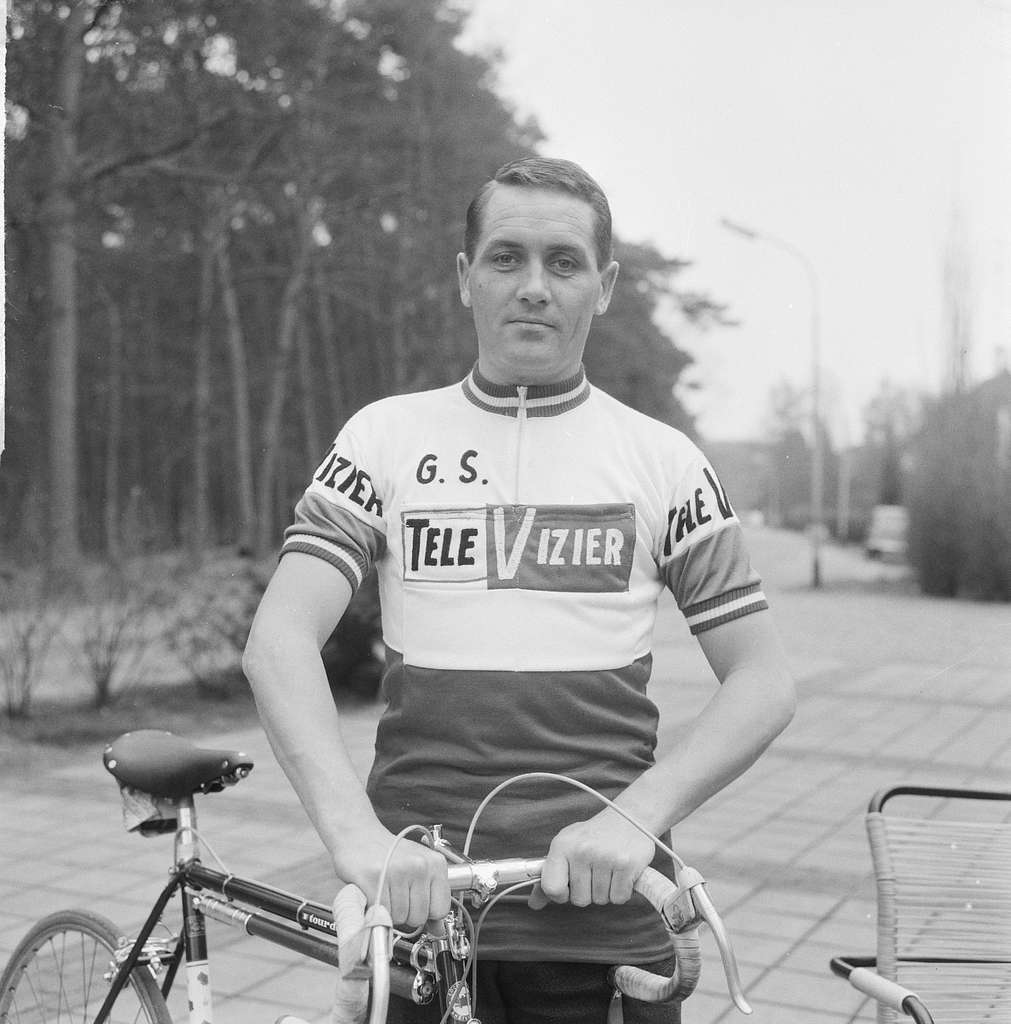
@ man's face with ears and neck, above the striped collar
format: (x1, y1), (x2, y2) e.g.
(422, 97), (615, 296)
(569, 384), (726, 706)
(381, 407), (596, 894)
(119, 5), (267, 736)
(457, 184), (618, 384)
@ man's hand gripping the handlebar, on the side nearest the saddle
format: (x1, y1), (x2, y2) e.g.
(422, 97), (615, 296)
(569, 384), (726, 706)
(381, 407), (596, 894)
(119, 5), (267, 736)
(335, 829), (450, 931)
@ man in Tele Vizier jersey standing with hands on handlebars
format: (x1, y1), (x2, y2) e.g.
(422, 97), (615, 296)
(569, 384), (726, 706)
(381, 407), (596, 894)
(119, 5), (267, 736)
(245, 158), (795, 1024)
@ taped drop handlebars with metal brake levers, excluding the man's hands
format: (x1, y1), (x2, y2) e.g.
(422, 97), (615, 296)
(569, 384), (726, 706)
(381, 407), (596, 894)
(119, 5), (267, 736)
(335, 858), (752, 1024)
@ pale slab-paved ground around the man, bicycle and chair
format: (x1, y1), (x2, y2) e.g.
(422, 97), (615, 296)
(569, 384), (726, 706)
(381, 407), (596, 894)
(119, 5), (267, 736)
(0, 531), (1011, 1024)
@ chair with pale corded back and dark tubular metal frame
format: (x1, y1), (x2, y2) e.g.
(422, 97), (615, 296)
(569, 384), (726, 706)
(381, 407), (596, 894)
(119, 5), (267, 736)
(831, 785), (1011, 1024)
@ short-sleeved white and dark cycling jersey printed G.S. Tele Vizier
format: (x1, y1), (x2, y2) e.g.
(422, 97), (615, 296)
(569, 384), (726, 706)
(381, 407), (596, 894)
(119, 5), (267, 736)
(283, 368), (767, 963)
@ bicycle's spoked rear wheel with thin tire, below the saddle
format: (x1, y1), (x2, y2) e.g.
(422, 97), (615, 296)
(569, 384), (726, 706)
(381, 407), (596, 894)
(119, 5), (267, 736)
(0, 910), (172, 1024)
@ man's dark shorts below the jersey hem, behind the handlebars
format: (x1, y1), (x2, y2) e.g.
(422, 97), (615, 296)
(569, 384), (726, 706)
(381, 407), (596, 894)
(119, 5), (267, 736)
(386, 959), (681, 1024)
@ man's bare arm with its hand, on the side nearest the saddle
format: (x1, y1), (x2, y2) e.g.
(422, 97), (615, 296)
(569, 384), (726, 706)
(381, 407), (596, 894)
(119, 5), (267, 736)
(243, 552), (450, 927)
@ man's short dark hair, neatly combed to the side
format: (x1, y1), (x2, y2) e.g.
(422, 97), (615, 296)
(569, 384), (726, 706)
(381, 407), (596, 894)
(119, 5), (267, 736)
(463, 157), (614, 267)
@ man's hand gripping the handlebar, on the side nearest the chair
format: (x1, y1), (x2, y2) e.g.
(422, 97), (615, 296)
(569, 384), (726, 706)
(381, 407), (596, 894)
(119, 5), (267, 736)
(529, 808), (655, 910)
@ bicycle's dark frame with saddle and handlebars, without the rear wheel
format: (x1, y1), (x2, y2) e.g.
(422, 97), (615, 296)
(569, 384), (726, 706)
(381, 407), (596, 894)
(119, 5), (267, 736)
(92, 731), (751, 1024)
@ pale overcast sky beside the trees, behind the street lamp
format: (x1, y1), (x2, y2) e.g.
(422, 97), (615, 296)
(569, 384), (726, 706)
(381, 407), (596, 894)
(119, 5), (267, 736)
(465, 0), (1011, 442)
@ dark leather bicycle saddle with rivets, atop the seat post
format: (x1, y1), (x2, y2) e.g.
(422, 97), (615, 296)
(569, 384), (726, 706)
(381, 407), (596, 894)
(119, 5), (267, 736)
(101, 729), (253, 799)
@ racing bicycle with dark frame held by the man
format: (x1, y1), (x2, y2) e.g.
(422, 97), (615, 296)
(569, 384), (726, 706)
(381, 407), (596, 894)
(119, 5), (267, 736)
(0, 729), (751, 1024)
